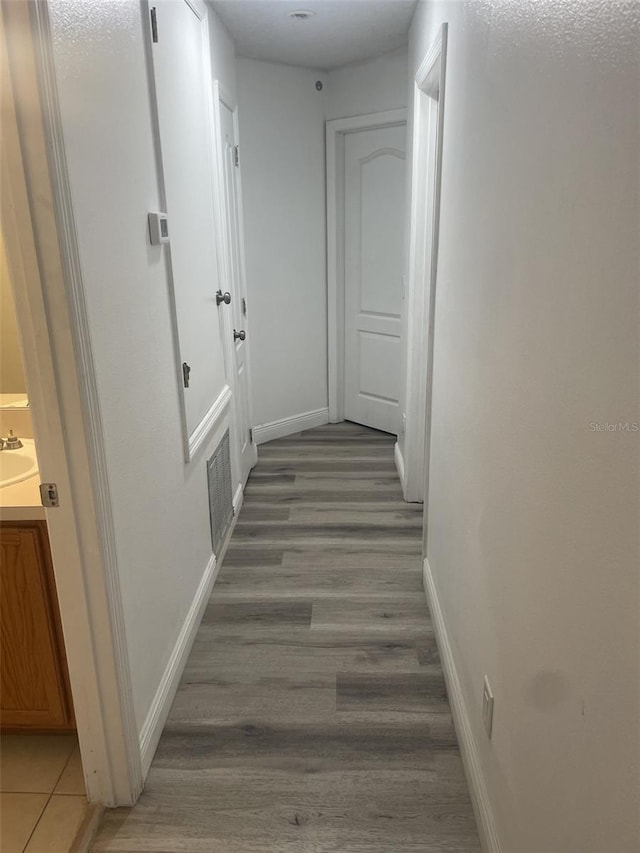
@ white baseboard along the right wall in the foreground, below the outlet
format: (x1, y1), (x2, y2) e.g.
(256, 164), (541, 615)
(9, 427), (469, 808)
(422, 559), (502, 853)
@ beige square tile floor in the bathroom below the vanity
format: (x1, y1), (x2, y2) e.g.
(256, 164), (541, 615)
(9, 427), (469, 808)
(0, 735), (89, 853)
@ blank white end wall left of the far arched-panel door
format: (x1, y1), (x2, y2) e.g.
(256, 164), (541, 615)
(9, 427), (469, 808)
(237, 59), (327, 424)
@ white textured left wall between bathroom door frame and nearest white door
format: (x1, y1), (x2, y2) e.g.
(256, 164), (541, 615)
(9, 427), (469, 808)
(50, 0), (234, 740)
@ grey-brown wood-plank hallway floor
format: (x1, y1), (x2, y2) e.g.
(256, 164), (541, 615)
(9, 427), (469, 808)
(93, 424), (480, 853)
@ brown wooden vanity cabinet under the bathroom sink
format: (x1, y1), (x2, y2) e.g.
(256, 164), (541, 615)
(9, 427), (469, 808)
(0, 521), (75, 732)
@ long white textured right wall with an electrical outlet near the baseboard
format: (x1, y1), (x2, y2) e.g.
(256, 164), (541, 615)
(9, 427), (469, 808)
(410, 0), (640, 853)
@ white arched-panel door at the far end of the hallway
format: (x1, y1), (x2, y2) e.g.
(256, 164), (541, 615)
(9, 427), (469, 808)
(344, 124), (406, 433)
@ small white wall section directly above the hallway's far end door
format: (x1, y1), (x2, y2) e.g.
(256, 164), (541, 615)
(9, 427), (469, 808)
(326, 49), (408, 119)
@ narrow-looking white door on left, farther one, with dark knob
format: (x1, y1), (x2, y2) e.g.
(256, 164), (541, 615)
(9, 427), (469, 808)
(220, 101), (257, 484)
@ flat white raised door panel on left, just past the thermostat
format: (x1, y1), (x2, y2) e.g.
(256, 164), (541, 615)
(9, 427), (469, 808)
(150, 0), (227, 452)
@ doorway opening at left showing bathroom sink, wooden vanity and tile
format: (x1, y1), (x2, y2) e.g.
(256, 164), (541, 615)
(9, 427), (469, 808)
(0, 218), (91, 851)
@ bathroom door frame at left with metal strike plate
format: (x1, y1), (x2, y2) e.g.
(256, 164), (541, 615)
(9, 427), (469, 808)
(0, 2), (143, 806)
